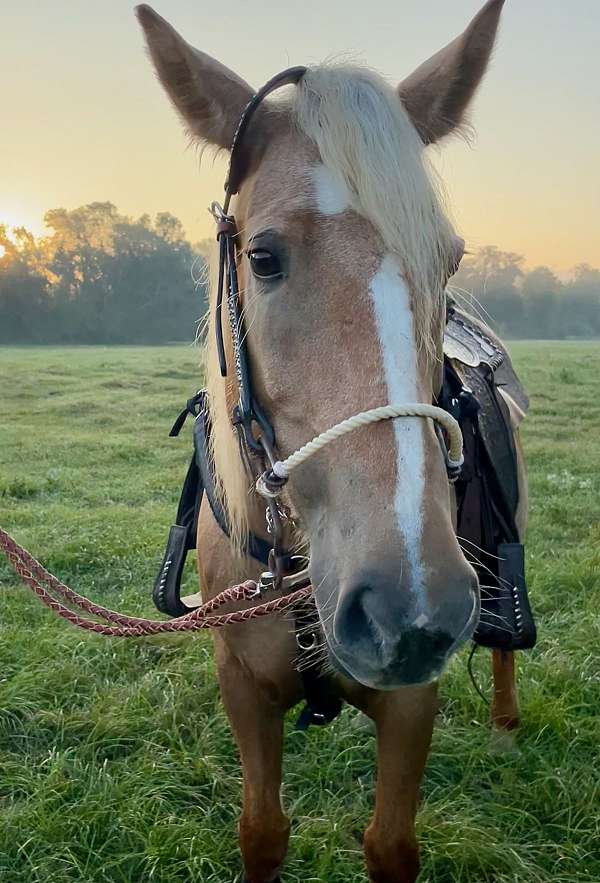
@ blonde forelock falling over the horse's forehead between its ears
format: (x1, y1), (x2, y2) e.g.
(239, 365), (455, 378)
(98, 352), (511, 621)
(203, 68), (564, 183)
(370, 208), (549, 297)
(293, 65), (454, 353)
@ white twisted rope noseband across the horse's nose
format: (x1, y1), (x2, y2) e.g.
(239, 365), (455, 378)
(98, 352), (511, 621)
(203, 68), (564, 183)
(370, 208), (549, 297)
(256, 402), (464, 498)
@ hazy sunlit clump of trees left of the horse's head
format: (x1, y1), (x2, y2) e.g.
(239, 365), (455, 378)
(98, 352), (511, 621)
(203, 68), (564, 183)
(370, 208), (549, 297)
(0, 202), (206, 343)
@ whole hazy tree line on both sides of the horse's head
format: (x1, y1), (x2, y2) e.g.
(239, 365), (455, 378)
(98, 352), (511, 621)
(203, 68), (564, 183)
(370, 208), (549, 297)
(0, 202), (600, 344)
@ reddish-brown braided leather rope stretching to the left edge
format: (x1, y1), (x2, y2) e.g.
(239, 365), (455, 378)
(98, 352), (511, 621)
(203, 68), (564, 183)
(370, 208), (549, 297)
(0, 528), (312, 638)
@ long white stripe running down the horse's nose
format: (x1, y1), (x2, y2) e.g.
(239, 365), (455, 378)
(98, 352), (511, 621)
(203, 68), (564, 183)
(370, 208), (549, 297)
(369, 255), (424, 597)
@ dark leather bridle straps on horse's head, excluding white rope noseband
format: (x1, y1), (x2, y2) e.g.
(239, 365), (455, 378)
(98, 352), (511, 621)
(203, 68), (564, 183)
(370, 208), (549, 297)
(210, 67), (462, 587)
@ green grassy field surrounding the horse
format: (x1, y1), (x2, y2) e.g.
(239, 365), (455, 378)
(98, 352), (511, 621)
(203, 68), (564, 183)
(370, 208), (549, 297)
(0, 343), (600, 883)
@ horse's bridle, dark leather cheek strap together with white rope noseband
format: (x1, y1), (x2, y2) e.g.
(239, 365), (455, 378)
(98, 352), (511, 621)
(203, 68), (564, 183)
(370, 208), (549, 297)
(210, 67), (463, 584)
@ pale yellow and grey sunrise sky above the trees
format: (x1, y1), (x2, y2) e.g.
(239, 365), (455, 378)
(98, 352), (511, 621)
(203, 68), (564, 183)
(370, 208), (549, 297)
(0, 0), (600, 274)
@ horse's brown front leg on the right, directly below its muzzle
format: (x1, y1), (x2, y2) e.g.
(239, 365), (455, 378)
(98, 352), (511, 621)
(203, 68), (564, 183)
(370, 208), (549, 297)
(364, 684), (437, 883)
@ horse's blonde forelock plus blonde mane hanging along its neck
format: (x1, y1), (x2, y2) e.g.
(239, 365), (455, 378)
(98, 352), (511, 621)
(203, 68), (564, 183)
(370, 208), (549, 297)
(205, 64), (454, 551)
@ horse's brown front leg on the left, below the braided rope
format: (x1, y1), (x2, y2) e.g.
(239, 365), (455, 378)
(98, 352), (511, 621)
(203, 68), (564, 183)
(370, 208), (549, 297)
(218, 640), (290, 883)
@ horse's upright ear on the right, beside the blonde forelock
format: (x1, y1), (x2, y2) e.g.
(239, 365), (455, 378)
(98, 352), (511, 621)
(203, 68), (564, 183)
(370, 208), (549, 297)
(398, 0), (504, 144)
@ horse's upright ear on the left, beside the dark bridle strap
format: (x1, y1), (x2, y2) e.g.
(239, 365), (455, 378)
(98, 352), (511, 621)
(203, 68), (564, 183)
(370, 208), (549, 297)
(135, 3), (253, 147)
